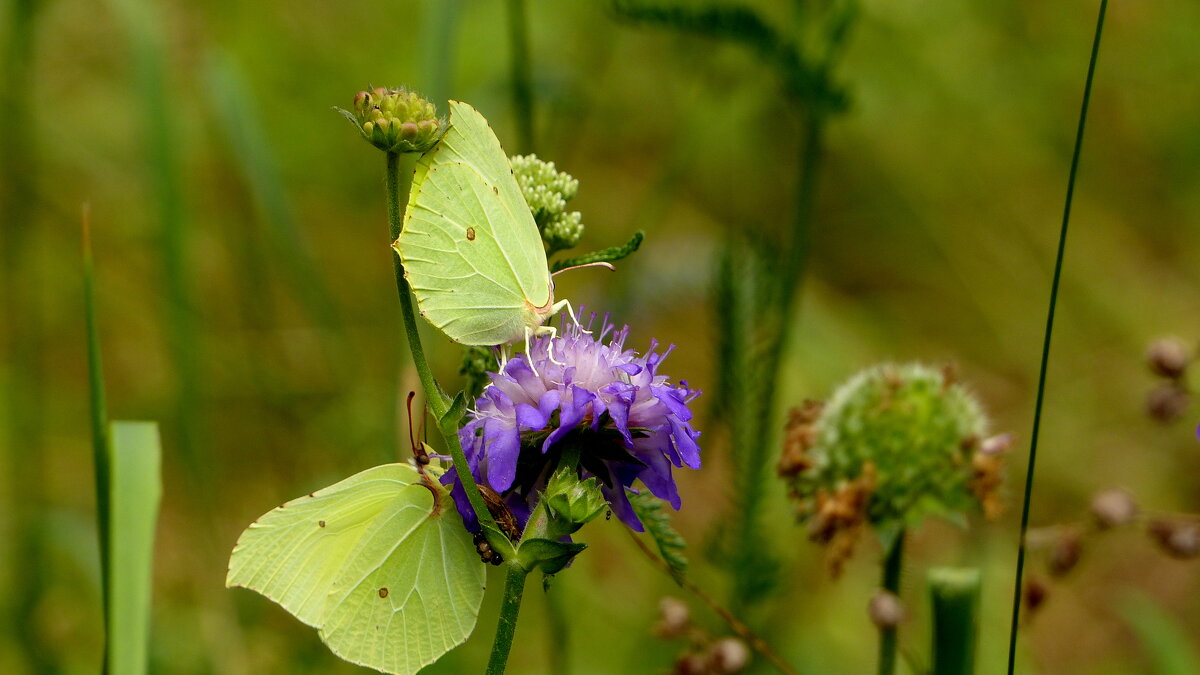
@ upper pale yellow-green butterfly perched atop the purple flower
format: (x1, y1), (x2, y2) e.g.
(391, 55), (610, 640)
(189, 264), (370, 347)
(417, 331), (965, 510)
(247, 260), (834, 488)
(392, 101), (570, 345)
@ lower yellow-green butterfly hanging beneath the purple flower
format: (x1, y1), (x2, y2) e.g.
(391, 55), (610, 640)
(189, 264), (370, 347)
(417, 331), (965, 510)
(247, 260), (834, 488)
(226, 464), (485, 674)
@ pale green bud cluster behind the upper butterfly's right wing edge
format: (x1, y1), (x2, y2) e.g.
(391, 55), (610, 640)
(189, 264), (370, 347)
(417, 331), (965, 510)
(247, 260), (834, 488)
(509, 155), (583, 256)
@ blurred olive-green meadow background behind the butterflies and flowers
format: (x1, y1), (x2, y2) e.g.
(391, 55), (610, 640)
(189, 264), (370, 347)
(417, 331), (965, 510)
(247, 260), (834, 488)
(0, 0), (1200, 674)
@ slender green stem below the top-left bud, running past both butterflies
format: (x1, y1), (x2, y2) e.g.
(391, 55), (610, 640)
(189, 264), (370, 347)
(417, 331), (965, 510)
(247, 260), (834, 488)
(385, 153), (499, 538)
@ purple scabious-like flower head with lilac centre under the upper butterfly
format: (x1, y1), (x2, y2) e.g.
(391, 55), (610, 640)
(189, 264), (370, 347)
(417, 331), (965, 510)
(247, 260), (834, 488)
(443, 316), (700, 531)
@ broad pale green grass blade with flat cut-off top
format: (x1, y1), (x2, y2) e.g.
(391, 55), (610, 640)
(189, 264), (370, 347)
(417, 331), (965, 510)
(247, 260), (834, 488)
(103, 422), (162, 674)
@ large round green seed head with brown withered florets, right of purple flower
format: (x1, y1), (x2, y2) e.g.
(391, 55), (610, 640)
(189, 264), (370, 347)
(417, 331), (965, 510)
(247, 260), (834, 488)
(790, 364), (1008, 550)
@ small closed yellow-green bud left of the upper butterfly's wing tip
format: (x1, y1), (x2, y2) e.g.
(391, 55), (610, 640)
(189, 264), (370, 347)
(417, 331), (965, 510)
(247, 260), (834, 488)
(337, 86), (446, 153)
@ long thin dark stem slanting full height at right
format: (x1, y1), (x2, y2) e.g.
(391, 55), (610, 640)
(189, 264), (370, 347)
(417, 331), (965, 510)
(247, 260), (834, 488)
(1008, 0), (1109, 675)
